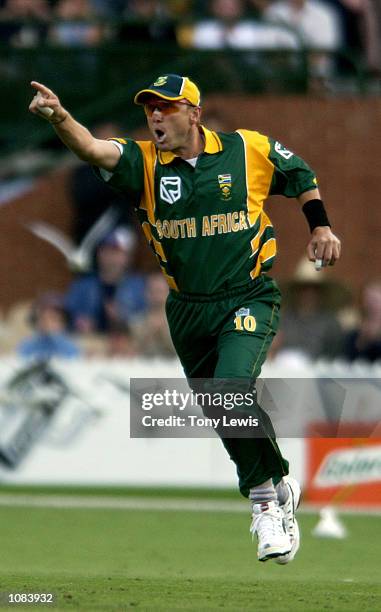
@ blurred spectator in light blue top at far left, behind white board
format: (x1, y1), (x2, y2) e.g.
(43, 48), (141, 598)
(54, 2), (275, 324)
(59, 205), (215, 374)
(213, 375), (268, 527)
(17, 293), (80, 360)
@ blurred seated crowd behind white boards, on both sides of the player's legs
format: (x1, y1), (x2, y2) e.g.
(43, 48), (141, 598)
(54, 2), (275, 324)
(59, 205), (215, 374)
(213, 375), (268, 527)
(5, 232), (381, 368)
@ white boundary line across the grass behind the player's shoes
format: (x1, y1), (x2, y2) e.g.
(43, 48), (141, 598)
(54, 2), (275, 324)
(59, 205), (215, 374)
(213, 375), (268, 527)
(0, 493), (381, 516)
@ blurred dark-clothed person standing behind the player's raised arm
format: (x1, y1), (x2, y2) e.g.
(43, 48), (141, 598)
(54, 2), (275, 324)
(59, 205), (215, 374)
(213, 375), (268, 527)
(68, 123), (135, 244)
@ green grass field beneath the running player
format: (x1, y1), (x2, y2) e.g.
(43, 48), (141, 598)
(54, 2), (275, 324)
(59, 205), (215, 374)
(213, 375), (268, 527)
(0, 489), (381, 612)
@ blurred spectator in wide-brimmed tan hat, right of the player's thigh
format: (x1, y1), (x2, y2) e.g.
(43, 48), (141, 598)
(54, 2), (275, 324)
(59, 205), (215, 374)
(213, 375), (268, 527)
(278, 259), (343, 360)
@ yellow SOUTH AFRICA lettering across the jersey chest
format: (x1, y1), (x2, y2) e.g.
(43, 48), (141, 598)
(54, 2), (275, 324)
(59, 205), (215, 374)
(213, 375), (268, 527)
(156, 210), (251, 240)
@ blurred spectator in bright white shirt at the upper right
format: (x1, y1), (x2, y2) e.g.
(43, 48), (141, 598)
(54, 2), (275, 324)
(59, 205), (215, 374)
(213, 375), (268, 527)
(264, 0), (343, 89)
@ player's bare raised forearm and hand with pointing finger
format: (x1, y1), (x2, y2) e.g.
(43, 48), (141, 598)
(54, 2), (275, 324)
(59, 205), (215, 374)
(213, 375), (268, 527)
(29, 81), (120, 171)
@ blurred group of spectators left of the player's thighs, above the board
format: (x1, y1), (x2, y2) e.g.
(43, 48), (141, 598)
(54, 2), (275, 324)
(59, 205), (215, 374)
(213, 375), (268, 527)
(9, 226), (175, 360)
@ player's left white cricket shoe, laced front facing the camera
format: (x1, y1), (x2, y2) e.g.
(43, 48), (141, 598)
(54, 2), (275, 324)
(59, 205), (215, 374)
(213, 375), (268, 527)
(250, 502), (291, 561)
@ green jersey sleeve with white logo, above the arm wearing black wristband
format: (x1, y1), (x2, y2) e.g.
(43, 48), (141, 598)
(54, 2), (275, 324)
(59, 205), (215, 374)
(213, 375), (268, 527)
(269, 138), (317, 198)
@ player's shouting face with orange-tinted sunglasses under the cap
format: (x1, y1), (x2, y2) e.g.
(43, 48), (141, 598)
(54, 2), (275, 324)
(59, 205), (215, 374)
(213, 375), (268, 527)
(144, 96), (200, 151)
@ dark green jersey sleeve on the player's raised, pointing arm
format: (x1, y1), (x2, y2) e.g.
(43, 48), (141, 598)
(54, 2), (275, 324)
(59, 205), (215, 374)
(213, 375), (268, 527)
(93, 138), (144, 199)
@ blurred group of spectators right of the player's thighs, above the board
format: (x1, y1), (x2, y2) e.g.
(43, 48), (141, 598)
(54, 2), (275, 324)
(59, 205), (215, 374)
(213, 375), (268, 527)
(271, 258), (381, 367)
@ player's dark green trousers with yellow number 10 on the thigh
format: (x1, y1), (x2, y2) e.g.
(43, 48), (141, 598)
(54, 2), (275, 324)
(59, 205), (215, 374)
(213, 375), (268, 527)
(166, 276), (288, 497)
